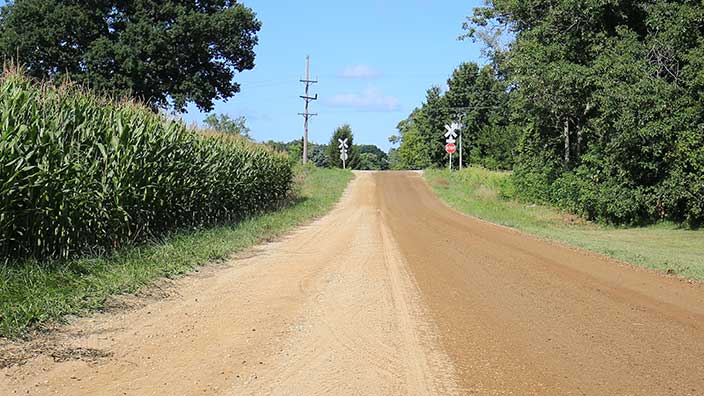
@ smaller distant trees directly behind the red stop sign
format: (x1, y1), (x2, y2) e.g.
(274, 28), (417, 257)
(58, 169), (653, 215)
(390, 63), (520, 169)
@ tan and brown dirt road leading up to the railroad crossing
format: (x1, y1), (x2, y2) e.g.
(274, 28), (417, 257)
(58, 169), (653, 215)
(0, 172), (704, 395)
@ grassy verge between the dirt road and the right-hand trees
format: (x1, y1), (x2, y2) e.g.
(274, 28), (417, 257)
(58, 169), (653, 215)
(425, 168), (704, 279)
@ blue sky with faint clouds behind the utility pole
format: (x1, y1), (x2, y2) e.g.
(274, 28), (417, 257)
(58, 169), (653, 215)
(184, 0), (482, 150)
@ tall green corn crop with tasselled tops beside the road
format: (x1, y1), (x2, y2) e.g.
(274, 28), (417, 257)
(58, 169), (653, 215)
(0, 73), (293, 262)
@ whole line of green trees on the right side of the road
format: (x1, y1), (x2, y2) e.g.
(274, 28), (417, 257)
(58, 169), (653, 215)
(390, 0), (704, 227)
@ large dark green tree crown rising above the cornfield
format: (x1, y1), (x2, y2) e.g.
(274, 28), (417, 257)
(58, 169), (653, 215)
(0, 0), (261, 111)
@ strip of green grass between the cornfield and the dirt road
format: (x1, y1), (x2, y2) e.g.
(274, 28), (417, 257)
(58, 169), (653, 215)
(0, 168), (353, 337)
